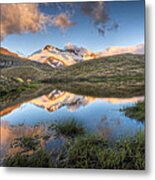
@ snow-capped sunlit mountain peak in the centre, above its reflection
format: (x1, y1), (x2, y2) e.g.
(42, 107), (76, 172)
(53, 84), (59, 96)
(28, 45), (96, 68)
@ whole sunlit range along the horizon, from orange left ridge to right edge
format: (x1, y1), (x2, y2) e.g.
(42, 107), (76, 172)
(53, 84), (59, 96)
(0, 43), (144, 68)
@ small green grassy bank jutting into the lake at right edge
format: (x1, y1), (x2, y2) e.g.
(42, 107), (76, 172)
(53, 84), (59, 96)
(123, 101), (145, 122)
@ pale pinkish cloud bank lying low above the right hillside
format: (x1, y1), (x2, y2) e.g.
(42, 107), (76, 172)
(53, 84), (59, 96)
(97, 44), (144, 57)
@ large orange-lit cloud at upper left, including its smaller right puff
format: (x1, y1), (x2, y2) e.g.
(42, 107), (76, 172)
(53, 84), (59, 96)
(0, 3), (74, 40)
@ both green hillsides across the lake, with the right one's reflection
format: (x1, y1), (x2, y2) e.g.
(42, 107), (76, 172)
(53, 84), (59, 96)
(0, 54), (145, 97)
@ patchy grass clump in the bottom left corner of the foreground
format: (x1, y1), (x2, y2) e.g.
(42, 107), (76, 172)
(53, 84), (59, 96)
(3, 136), (52, 167)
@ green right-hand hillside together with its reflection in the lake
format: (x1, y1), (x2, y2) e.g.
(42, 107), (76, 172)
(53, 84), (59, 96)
(44, 54), (145, 97)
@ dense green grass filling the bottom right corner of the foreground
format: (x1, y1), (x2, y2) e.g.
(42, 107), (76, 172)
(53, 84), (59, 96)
(60, 133), (145, 170)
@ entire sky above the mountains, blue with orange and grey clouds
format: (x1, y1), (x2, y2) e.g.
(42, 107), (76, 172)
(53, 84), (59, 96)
(0, 0), (144, 56)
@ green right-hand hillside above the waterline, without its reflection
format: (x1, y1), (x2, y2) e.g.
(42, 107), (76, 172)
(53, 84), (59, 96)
(46, 54), (145, 82)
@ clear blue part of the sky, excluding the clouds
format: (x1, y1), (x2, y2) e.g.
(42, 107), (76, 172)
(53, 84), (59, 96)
(1, 0), (144, 56)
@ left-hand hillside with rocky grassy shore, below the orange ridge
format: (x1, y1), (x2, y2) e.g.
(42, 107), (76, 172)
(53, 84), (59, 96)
(0, 54), (52, 97)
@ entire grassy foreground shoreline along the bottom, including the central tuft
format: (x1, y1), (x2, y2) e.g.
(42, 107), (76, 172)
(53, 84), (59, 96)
(4, 120), (145, 170)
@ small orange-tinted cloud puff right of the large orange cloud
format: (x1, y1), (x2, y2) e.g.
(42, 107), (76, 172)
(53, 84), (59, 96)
(53, 13), (76, 30)
